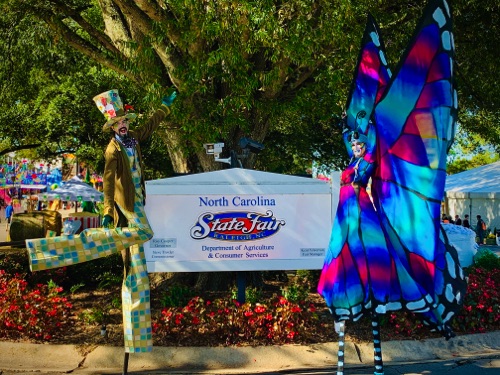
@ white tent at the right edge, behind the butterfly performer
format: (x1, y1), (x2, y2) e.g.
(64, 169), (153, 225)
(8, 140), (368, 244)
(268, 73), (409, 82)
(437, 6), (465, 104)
(445, 162), (500, 231)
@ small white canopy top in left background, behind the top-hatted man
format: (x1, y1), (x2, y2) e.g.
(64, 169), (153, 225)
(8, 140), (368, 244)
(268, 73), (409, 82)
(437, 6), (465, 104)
(38, 177), (103, 202)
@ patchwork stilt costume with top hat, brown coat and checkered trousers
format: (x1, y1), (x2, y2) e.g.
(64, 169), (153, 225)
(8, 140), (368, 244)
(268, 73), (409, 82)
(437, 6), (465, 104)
(26, 90), (175, 353)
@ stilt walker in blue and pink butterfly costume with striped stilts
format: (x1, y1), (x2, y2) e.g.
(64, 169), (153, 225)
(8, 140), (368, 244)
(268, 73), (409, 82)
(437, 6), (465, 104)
(318, 0), (466, 375)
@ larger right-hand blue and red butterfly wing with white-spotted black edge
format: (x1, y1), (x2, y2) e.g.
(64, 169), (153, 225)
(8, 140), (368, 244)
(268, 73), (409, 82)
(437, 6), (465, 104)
(372, 0), (463, 332)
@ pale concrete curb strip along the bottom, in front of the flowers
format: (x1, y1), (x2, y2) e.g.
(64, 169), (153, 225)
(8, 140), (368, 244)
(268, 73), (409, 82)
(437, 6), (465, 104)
(0, 331), (500, 374)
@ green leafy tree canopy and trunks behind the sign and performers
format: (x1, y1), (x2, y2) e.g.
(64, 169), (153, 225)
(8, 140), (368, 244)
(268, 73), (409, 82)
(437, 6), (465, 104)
(0, 0), (500, 176)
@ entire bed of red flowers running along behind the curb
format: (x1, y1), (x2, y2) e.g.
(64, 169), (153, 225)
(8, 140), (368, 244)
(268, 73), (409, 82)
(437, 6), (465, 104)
(0, 267), (500, 346)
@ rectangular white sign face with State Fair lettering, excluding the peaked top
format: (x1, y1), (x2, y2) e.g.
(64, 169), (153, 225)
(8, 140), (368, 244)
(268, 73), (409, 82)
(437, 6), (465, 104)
(145, 194), (331, 272)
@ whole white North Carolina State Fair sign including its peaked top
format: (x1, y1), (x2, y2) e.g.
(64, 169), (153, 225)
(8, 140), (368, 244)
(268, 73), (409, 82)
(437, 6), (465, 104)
(144, 169), (332, 272)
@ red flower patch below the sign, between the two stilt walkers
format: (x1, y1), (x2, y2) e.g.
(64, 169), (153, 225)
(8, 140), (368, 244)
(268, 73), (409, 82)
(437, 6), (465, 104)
(153, 296), (318, 345)
